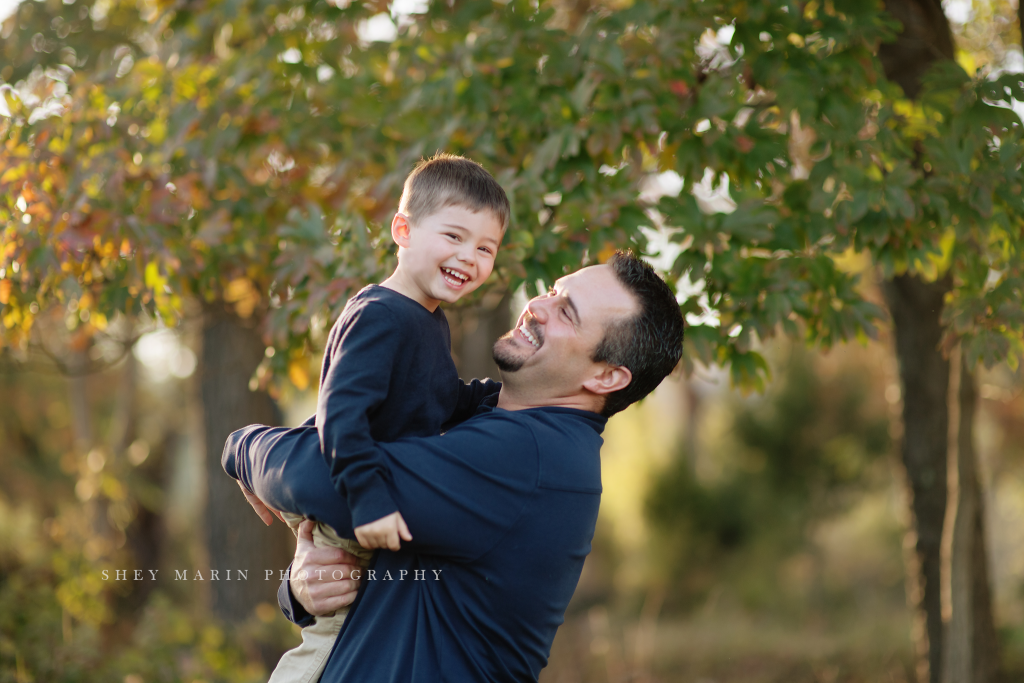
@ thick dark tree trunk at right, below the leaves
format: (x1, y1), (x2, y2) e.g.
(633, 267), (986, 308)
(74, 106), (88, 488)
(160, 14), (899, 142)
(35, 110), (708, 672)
(885, 275), (950, 683)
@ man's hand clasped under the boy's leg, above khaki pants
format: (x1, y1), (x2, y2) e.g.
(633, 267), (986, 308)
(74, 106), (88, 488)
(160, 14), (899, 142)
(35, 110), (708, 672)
(289, 519), (362, 616)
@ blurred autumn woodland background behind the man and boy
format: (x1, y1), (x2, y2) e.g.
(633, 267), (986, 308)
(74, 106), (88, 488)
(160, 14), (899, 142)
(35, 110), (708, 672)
(0, 0), (1024, 683)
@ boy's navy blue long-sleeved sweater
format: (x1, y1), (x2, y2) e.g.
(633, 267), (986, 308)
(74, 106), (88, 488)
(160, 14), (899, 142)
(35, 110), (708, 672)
(315, 285), (501, 530)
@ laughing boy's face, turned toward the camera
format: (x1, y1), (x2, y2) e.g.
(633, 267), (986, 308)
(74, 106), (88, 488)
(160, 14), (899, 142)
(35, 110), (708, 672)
(391, 206), (502, 308)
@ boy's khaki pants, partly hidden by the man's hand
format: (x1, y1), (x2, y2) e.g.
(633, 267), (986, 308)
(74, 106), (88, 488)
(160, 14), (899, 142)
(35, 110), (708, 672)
(269, 512), (374, 683)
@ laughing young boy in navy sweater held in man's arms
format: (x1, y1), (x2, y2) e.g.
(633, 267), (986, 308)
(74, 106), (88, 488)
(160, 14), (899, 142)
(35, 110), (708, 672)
(262, 154), (510, 683)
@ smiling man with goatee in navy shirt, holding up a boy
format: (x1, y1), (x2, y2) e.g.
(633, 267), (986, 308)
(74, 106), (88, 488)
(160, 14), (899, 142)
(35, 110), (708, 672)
(223, 252), (683, 683)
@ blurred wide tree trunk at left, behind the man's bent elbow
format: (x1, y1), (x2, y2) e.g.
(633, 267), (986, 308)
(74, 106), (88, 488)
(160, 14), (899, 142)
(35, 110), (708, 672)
(200, 302), (294, 622)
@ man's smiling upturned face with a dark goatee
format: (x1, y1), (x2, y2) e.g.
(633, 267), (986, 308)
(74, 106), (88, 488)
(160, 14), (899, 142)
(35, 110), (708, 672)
(495, 265), (638, 394)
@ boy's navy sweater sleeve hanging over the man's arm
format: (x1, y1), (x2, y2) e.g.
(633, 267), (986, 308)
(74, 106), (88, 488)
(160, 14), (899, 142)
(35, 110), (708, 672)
(316, 301), (408, 526)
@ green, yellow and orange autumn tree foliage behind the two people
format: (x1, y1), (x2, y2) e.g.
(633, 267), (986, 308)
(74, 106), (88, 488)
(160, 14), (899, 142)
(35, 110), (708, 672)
(0, 0), (1024, 680)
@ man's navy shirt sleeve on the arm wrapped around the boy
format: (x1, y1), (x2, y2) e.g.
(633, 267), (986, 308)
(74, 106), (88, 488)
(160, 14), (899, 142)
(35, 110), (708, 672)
(223, 412), (540, 561)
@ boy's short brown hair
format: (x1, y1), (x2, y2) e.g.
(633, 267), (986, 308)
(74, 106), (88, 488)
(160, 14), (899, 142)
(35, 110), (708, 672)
(398, 153), (511, 232)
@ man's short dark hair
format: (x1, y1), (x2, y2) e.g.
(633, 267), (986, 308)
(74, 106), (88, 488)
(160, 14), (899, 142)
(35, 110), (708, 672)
(593, 251), (683, 417)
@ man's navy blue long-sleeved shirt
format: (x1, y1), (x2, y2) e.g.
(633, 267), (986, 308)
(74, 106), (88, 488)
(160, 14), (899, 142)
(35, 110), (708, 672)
(223, 397), (605, 683)
